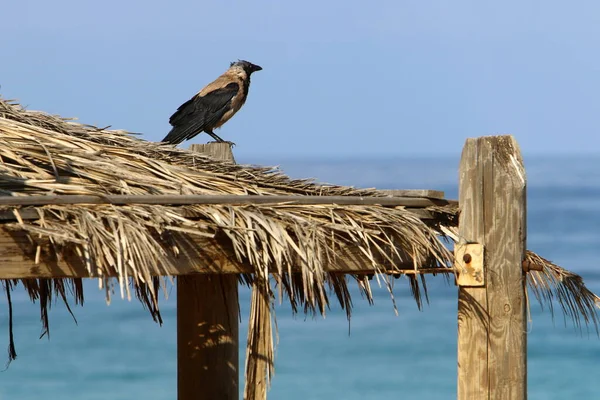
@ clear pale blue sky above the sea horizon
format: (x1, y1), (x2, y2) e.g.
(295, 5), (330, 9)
(0, 0), (600, 162)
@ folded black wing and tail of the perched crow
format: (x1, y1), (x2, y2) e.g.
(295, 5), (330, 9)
(162, 82), (240, 144)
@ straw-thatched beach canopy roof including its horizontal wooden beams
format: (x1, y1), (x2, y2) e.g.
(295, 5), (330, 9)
(0, 99), (598, 400)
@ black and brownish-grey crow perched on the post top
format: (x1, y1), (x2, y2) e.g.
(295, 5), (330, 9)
(162, 60), (262, 144)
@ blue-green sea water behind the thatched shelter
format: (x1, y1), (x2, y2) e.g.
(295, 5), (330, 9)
(0, 155), (600, 400)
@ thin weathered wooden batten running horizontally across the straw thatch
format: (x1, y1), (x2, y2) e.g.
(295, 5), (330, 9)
(0, 195), (452, 207)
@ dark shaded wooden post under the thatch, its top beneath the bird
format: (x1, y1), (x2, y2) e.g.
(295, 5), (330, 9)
(177, 143), (239, 400)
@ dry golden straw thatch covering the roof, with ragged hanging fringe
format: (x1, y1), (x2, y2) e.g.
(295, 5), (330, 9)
(0, 99), (598, 400)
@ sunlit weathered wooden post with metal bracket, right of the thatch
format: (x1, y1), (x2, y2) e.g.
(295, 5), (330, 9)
(458, 136), (527, 400)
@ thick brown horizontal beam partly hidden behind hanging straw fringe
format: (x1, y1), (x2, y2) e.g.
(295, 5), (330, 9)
(0, 228), (446, 279)
